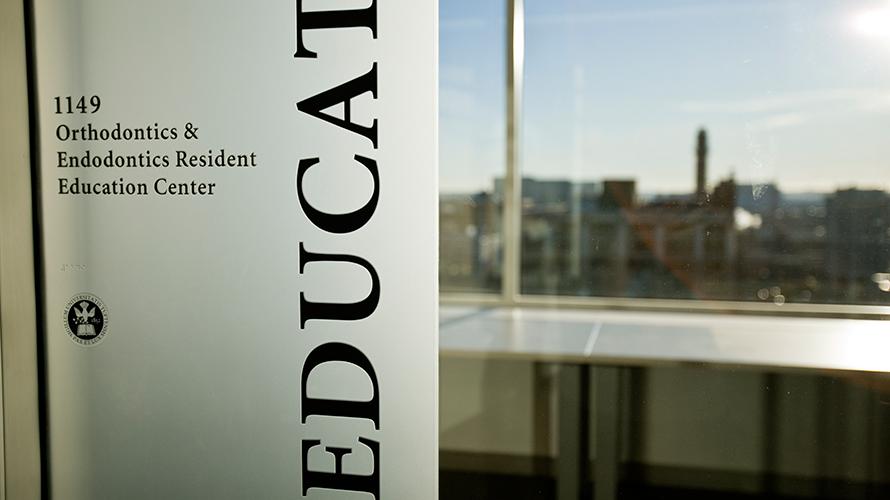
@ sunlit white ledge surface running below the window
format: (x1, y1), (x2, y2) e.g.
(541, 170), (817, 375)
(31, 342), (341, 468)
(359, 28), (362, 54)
(439, 305), (890, 373)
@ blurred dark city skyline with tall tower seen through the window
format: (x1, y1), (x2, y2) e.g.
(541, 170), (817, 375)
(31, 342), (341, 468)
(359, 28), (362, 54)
(439, 125), (890, 305)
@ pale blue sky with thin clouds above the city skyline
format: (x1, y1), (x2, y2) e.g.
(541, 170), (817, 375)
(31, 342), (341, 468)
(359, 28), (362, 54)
(440, 0), (890, 193)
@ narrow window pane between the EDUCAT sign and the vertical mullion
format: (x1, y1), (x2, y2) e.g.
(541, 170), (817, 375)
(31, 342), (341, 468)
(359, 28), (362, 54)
(439, 0), (506, 292)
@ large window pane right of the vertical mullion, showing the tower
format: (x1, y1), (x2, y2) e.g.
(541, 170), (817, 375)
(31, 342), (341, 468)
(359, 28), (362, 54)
(521, 0), (890, 305)
